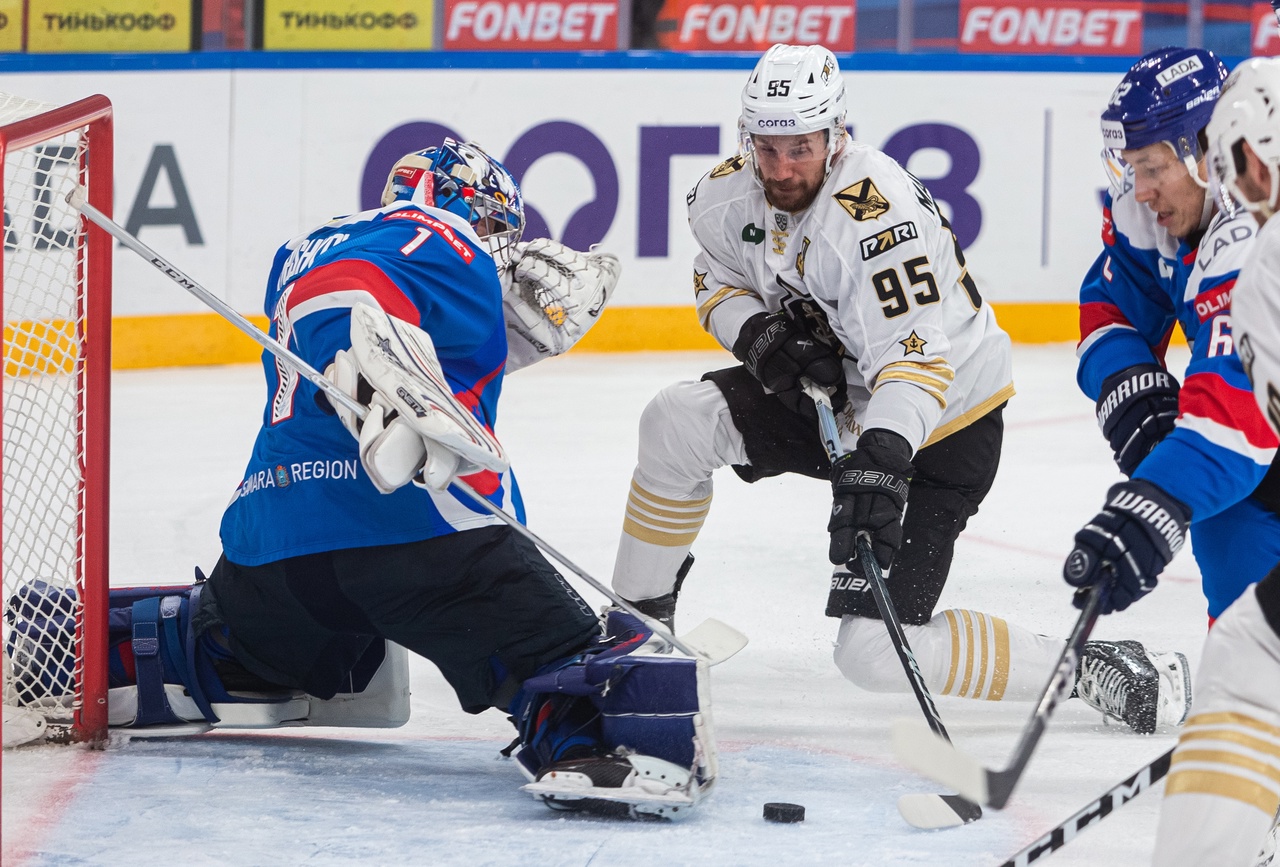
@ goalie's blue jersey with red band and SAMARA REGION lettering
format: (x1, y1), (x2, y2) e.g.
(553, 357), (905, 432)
(221, 202), (524, 566)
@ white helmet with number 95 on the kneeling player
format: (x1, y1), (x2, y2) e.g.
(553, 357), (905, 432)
(737, 44), (846, 169)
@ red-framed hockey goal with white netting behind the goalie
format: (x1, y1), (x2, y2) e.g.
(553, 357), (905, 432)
(0, 93), (113, 747)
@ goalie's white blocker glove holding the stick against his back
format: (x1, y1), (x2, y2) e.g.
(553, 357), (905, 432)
(325, 304), (508, 493)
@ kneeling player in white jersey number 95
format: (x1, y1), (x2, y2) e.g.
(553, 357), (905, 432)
(613, 45), (1177, 731)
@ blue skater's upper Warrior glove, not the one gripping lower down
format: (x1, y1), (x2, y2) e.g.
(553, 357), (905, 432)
(1098, 364), (1178, 476)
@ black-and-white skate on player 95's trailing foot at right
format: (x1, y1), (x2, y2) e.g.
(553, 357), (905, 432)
(1073, 640), (1192, 735)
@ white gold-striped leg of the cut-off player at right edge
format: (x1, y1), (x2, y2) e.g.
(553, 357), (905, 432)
(1153, 587), (1280, 867)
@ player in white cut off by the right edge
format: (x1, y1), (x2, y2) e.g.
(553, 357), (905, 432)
(1155, 58), (1280, 867)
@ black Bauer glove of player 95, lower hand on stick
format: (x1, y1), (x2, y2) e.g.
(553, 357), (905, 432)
(827, 429), (913, 569)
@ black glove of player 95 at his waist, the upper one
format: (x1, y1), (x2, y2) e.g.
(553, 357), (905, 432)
(733, 311), (846, 420)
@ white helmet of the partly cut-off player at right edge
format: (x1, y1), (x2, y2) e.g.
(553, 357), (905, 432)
(1208, 58), (1280, 216)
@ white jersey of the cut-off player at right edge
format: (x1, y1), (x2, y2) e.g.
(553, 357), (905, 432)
(1231, 210), (1280, 435)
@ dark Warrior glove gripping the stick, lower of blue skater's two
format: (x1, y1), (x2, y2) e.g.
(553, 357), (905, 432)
(1062, 479), (1192, 615)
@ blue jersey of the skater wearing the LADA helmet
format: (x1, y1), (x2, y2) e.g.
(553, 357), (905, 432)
(1076, 172), (1276, 521)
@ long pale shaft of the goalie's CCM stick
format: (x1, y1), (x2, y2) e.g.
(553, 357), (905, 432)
(68, 187), (732, 661)
